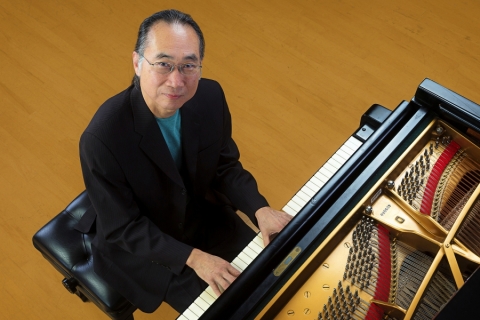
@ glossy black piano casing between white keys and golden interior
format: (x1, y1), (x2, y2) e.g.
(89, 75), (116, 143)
(200, 79), (480, 320)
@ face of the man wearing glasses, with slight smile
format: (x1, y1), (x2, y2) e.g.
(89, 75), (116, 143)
(133, 22), (201, 118)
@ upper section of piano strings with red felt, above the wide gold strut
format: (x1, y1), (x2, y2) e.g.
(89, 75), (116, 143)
(397, 127), (480, 255)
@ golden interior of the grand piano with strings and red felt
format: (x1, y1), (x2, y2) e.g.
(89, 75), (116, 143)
(272, 121), (480, 320)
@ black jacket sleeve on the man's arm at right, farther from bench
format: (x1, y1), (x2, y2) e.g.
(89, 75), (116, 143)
(216, 86), (268, 225)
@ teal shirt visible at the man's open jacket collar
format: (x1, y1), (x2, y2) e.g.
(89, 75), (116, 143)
(155, 110), (182, 170)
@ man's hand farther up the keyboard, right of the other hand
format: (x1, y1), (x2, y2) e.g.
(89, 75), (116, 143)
(255, 207), (292, 246)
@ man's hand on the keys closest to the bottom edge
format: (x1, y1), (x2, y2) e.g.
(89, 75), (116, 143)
(187, 249), (240, 296)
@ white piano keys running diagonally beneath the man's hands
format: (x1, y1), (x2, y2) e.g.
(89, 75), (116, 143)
(177, 136), (362, 320)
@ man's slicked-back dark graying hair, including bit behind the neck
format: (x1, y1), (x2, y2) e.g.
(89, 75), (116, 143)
(132, 9), (205, 89)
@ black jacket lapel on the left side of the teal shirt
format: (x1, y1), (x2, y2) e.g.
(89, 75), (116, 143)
(130, 88), (184, 187)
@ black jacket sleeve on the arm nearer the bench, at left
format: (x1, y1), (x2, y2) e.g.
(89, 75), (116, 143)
(80, 132), (193, 274)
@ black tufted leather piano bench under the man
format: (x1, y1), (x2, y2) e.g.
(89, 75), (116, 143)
(33, 191), (137, 320)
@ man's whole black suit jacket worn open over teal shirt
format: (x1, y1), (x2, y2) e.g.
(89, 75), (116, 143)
(80, 79), (268, 312)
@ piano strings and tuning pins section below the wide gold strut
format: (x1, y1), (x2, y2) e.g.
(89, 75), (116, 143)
(318, 216), (438, 320)
